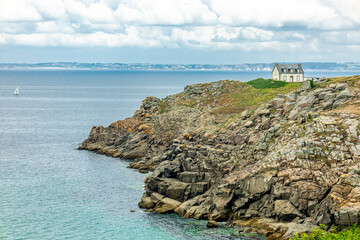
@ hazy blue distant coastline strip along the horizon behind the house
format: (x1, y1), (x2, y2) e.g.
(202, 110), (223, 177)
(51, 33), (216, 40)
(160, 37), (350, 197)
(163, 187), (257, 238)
(0, 62), (360, 72)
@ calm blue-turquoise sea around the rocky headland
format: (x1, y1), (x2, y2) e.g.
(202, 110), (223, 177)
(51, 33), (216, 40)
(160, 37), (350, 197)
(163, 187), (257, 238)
(0, 71), (359, 239)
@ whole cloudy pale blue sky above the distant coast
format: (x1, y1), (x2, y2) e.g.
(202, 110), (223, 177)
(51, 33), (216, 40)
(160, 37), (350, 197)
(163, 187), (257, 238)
(0, 0), (360, 64)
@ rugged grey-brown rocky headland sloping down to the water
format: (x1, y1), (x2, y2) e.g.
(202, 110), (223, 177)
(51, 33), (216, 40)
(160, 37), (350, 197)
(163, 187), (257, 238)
(80, 77), (360, 239)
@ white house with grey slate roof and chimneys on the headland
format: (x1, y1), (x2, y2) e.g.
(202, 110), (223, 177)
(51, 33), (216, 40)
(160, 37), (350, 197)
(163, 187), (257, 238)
(272, 63), (304, 82)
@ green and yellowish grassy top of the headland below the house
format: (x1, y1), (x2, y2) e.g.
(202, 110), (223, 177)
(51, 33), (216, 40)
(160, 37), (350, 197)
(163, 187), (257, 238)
(160, 78), (302, 114)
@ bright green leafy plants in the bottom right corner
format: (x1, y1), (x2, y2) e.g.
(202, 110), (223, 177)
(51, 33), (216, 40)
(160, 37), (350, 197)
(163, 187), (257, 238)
(290, 225), (360, 240)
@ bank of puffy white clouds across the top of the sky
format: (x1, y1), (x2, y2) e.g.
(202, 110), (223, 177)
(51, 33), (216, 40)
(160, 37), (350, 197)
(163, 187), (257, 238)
(0, 0), (360, 54)
